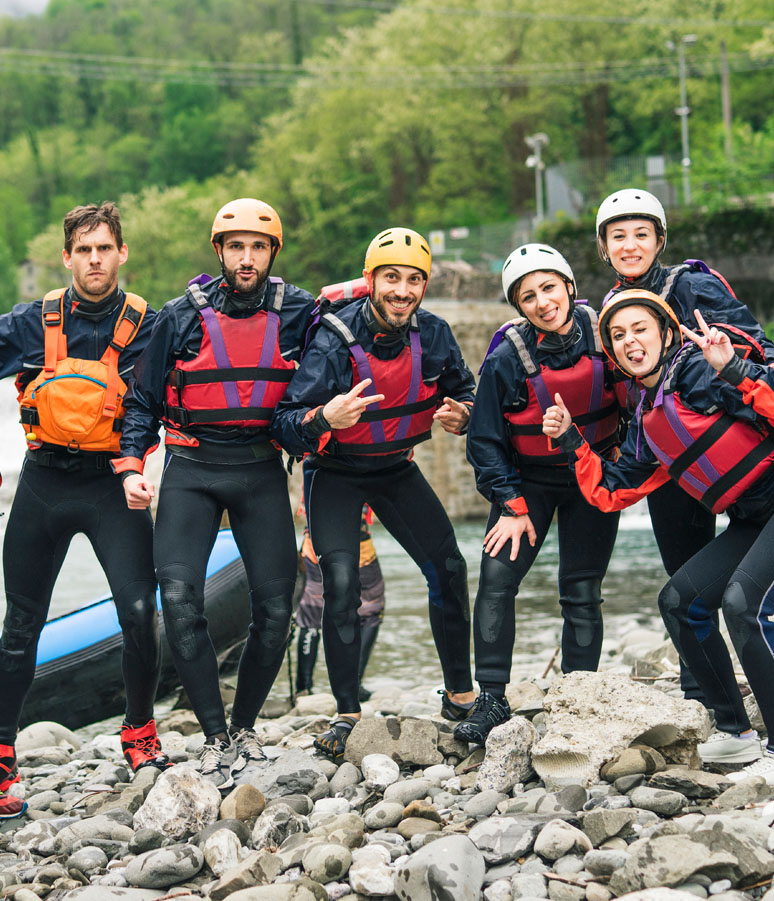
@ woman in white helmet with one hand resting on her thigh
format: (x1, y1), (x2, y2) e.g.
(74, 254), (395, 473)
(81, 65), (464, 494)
(454, 244), (619, 744)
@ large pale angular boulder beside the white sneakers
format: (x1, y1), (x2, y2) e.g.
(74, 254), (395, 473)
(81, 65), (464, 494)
(532, 672), (710, 790)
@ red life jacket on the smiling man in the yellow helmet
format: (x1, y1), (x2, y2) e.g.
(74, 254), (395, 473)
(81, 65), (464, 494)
(322, 313), (438, 454)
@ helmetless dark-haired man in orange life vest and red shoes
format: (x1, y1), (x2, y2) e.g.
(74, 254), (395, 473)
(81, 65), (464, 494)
(0, 203), (168, 818)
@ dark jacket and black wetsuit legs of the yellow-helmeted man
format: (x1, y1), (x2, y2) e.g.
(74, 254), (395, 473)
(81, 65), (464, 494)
(272, 299), (474, 713)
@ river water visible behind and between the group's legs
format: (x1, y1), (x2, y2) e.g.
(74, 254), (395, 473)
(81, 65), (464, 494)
(0, 380), (665, 687)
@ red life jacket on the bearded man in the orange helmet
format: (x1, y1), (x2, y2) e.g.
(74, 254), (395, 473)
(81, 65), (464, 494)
(165, 279), (295, 429)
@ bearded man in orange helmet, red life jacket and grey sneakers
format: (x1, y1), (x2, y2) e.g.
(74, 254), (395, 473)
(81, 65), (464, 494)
(114, 198), (314, 789)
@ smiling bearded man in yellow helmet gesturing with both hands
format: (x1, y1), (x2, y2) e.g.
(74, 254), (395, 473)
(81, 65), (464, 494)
(272, 228), (474, 759)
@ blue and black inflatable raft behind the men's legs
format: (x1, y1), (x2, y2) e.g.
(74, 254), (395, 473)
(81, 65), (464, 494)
(21, 529), (250, 729)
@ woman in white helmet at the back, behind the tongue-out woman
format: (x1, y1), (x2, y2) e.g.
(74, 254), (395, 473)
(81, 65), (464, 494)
(596, 188), (774, 763)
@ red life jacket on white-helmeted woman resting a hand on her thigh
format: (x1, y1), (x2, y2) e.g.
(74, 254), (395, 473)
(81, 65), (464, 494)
(503, 306), (620, 466)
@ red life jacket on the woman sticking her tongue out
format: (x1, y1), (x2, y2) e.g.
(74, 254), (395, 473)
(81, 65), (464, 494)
(641, 348), (774, 513)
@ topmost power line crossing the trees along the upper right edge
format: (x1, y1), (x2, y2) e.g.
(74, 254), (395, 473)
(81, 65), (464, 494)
(297, 0), (771, 30)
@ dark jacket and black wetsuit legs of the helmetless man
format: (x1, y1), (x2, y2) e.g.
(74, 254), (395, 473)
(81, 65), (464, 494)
(0, 290), (160, 744)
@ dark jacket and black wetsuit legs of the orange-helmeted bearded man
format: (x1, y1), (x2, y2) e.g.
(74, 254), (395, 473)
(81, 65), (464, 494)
(117, 279), (314, 736)
